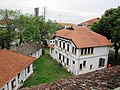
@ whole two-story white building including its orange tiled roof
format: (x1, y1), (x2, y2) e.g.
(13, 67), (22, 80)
(50, 26), (111, 75)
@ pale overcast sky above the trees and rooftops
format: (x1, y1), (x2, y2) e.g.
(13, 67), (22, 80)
(0, 0), (120, 24)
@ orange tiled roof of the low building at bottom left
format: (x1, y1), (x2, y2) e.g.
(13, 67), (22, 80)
(0, 50), (35, 88)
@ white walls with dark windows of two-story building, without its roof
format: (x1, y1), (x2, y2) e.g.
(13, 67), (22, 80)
(50, 26), (109, 75)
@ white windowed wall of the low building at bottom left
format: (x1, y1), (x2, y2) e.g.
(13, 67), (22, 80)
(0, 64), (33, 90)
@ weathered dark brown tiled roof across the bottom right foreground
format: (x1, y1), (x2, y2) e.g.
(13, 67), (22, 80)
(21, 65), (120, 90)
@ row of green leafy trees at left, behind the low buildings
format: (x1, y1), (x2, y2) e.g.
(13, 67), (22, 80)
(0, 9), (63, 49)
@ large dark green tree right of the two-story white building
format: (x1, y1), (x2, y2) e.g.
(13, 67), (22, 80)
(91, 6), (120, 58)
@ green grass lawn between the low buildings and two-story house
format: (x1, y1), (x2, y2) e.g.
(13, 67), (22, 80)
(23, 49), (72, 87)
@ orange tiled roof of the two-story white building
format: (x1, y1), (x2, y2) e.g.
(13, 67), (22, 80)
(54, 26), (112, 48)
